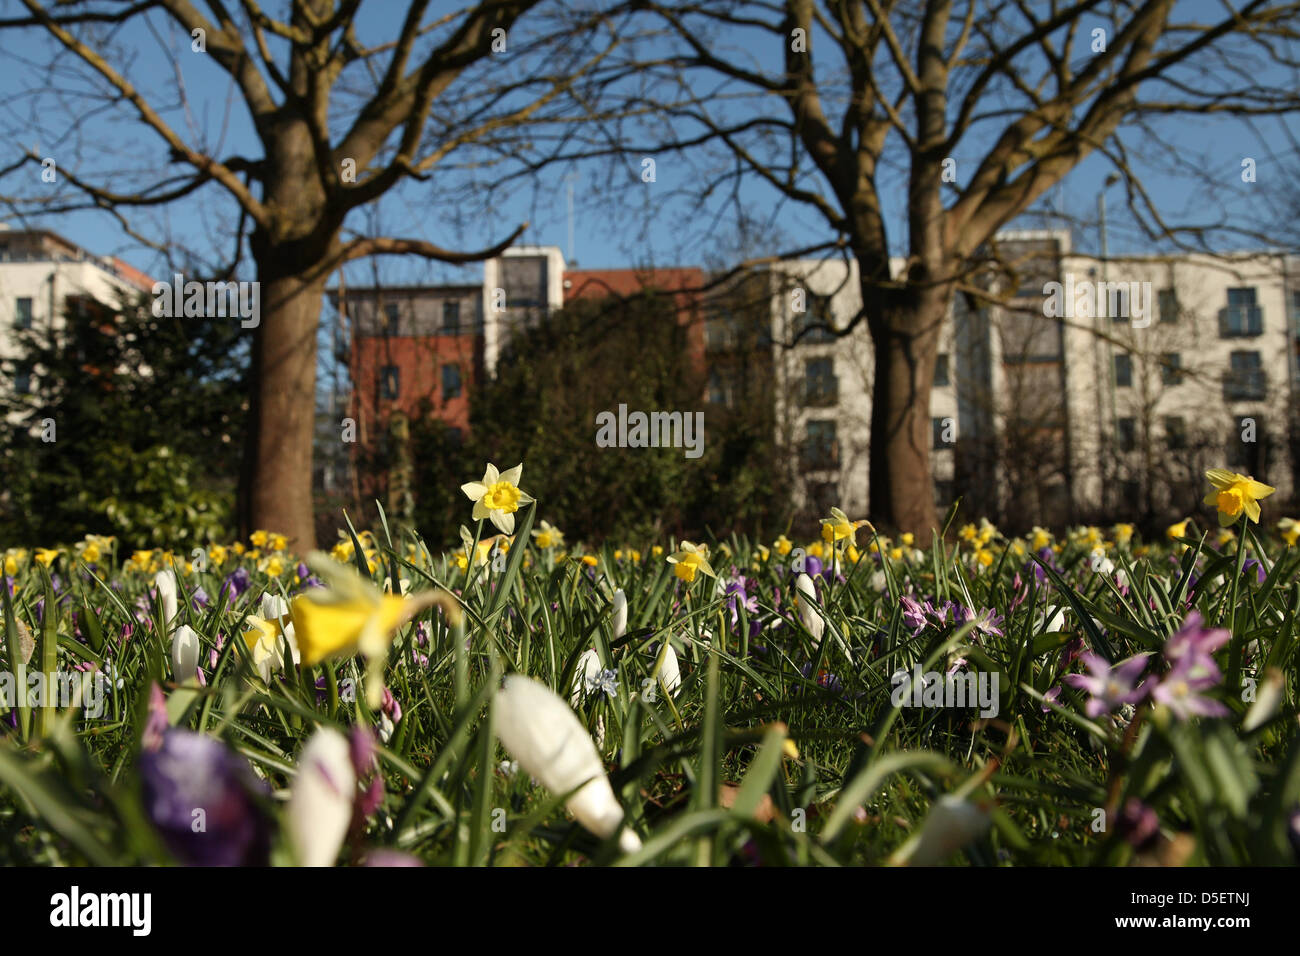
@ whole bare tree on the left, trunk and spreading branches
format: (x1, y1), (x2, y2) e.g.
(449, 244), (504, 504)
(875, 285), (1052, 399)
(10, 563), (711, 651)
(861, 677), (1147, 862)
(0, 0), (618, 546)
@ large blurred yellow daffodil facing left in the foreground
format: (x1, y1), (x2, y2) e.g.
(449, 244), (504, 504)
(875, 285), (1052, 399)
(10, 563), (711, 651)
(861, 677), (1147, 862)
(291, 551), (462, 710)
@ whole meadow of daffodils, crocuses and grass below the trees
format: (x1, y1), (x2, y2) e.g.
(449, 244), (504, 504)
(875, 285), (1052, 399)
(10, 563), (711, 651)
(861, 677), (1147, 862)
(0, 464), (1300, 866)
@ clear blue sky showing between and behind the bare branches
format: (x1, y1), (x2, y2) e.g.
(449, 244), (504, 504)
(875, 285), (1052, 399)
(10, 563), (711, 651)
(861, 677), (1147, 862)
(0, 0), (1300, 284)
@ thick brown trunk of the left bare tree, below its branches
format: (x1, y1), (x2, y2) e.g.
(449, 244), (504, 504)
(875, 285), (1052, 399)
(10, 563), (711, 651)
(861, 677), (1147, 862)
(246, 265), (325, 554)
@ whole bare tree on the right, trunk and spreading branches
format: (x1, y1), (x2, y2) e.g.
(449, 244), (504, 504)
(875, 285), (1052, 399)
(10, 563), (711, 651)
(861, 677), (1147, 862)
(616, 0), (1300, 533)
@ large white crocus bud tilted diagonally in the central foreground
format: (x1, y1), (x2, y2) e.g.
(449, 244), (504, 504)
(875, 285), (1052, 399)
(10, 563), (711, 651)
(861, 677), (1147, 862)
(494, 674), (641, 853)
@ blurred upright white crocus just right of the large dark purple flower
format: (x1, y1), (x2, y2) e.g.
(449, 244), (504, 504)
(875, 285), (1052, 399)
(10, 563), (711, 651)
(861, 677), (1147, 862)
(285, 727), (356, 866)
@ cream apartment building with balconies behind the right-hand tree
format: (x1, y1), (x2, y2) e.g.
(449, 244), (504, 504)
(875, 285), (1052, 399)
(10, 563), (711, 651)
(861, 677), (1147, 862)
(770, 232), (1300, 524)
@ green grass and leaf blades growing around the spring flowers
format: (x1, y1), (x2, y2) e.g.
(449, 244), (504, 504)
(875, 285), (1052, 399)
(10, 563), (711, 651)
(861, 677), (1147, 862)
(0, 506), (1300, 866)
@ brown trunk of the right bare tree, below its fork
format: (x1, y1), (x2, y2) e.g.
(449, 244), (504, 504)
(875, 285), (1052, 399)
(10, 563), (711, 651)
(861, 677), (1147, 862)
(865, 290), (948, 542)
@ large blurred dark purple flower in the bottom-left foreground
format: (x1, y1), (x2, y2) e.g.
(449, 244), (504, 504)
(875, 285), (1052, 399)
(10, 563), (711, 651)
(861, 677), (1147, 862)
(140, 727), (270, 866)
